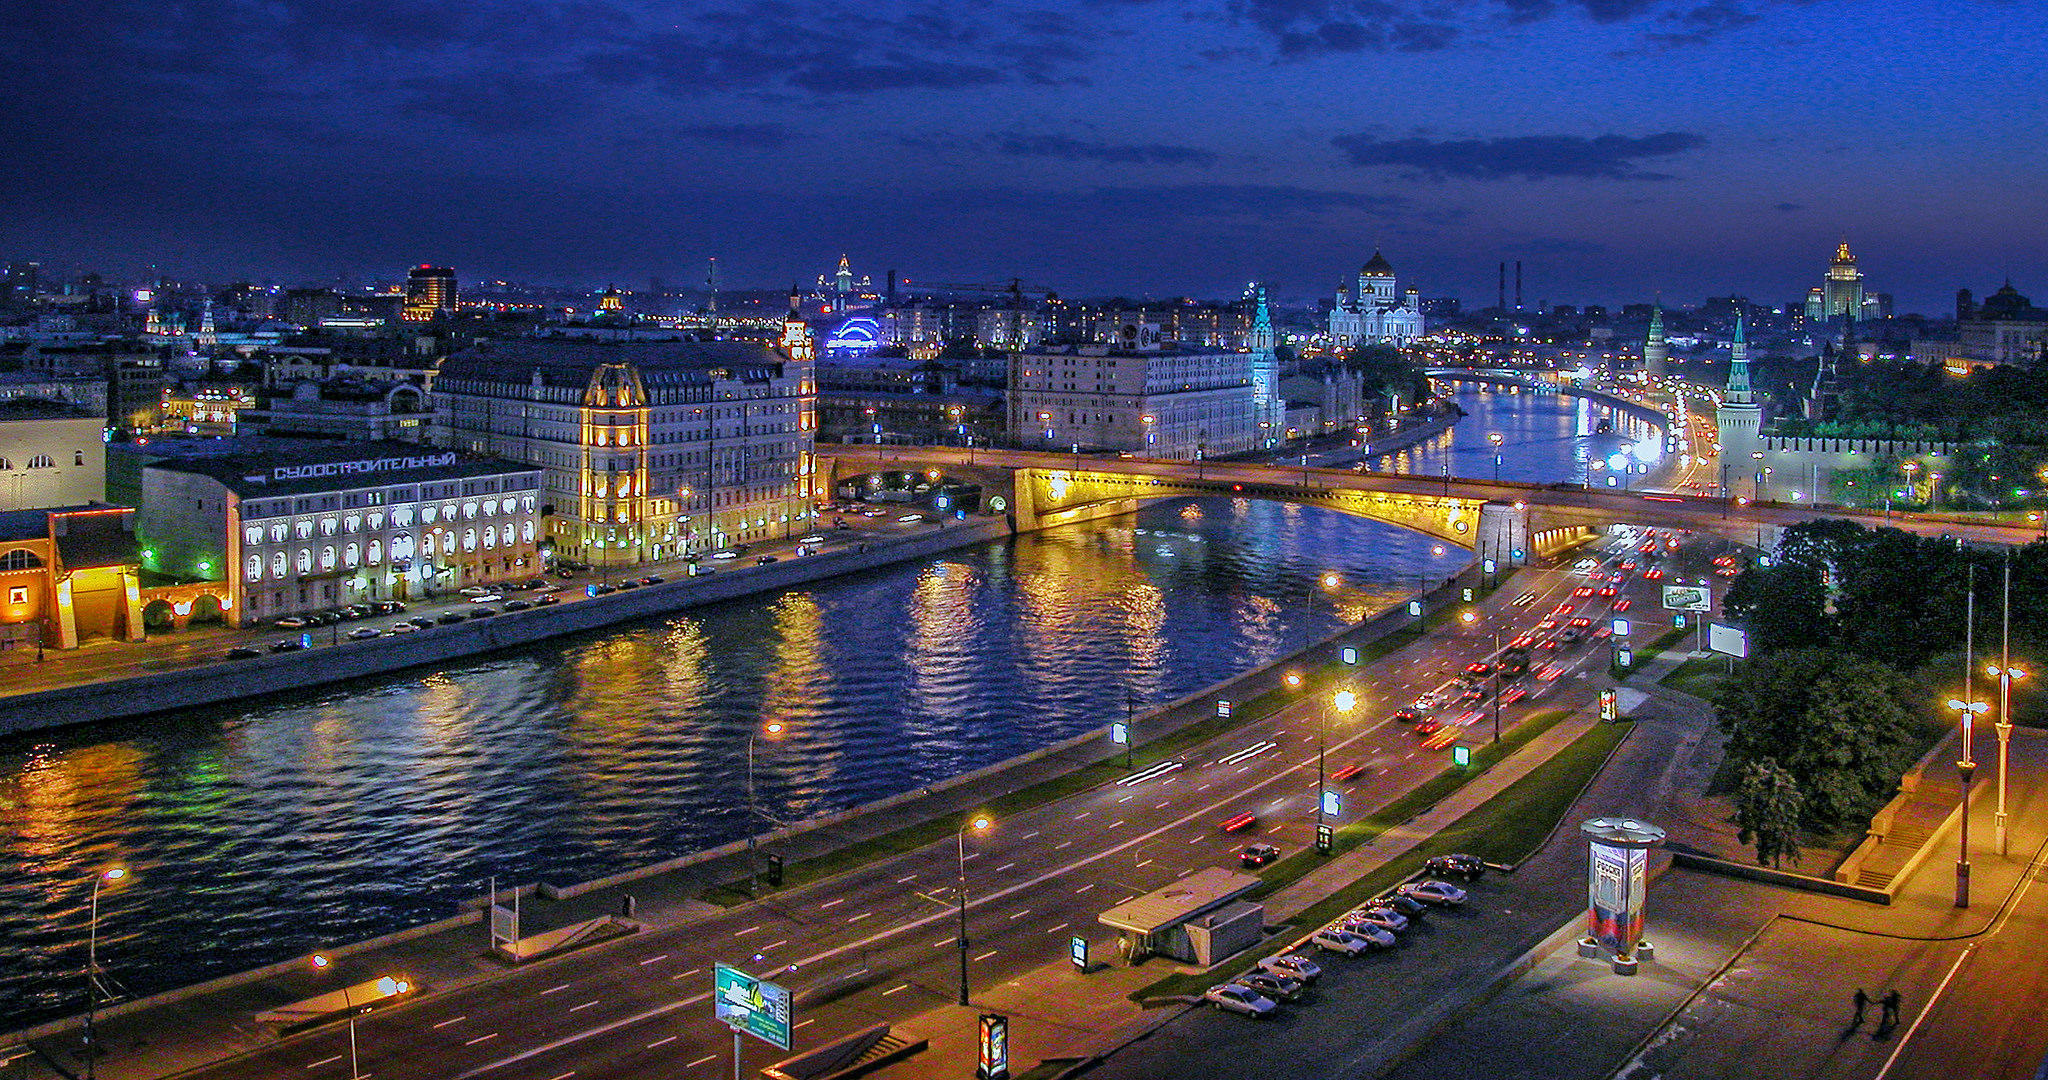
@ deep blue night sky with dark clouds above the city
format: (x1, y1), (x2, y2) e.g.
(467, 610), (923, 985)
(0, 0), (2048, 311)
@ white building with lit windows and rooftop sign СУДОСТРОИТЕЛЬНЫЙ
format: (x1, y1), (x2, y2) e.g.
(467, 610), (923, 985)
(135, 441), (541, 625)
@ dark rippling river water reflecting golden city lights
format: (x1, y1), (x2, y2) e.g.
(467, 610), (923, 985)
(0, 391), (1622, 1031)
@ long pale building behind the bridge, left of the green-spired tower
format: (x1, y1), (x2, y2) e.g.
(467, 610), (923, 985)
(1008, 342), (1260, 461)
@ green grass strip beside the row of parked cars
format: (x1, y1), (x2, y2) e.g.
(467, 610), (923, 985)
(1130, 721), (1632, 1002)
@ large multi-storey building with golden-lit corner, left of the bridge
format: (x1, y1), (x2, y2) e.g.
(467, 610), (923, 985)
(434, 311), (817, 566)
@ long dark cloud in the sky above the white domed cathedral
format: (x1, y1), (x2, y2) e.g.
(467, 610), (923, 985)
(1331, 131), (1706, 180)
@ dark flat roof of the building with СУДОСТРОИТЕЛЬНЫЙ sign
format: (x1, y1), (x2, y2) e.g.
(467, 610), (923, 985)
(145, 439), (539, 498)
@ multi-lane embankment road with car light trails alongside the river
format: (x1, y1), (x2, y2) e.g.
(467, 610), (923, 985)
(136, 557), (1606, 1080)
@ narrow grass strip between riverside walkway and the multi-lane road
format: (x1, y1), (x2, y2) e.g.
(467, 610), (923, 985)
(705, 625), (1441, 908)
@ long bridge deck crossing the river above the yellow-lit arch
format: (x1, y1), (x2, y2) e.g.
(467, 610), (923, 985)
(819, 447), (2038, 545)
